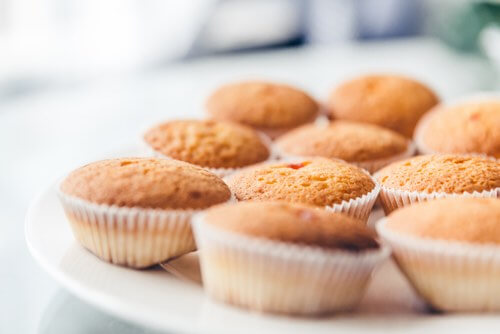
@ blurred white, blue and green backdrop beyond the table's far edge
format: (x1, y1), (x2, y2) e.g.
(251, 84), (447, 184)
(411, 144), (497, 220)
(0, 0), (500, 101)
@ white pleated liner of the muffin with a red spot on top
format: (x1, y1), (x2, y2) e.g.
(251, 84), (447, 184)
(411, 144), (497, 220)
(224, 157), (380, 223)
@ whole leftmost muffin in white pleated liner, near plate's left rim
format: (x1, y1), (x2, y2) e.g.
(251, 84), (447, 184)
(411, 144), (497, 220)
(59, 158), (231, 268)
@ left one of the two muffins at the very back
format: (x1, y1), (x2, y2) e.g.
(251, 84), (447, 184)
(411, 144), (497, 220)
(206, 81), (319, 138)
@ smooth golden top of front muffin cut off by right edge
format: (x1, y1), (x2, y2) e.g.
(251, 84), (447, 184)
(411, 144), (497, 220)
(386, 197), (500, 244)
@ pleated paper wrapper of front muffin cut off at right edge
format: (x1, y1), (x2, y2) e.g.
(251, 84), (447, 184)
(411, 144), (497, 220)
(376, 218), (500, 312)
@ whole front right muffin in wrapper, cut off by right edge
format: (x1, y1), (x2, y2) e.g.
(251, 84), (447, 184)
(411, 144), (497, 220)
(377, 197), (500, 312)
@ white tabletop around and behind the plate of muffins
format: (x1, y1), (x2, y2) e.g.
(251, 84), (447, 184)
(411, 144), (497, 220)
(0, 39), (498, 334)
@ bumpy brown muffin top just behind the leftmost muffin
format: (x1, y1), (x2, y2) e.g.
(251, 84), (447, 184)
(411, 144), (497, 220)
(144, 120), (269, 168)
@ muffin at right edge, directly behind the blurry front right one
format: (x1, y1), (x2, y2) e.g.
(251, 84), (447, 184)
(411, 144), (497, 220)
(375, 154), (500, 213)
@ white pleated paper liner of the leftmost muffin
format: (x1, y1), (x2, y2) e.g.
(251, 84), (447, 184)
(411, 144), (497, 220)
(57, 182), (234, 268)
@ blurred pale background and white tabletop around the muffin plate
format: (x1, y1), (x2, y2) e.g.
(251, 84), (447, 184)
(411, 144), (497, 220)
(0, 0), (500, 333)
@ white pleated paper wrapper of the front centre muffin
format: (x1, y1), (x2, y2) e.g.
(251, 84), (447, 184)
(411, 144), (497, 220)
(193, 214), (390, 315)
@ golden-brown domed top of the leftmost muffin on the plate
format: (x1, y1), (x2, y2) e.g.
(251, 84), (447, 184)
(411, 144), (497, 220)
(61, 158), (231, 209)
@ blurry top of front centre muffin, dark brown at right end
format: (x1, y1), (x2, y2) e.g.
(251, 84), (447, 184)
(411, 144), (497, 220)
(204, 201), (378, 251)
